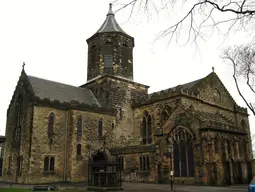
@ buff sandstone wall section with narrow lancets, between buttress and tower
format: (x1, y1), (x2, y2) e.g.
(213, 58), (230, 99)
(67, 110), (116, 182)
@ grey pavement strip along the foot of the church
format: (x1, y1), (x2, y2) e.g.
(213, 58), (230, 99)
(0, 183), (248, 192)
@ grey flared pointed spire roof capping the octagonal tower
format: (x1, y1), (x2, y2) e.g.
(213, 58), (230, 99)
(97, 4), (126, 34)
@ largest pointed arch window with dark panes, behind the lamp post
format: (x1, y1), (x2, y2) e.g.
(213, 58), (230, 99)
(173, 128), (194, 177)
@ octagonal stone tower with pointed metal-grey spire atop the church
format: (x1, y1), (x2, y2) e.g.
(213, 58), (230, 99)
(87, 4), (134, 81)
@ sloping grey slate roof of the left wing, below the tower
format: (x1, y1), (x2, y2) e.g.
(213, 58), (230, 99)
(27, 75), (101, 107)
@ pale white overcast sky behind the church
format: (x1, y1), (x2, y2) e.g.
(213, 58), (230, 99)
(0, 0), (255, 135)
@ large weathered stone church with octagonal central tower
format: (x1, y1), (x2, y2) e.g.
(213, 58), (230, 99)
(2, 5), (252, 185)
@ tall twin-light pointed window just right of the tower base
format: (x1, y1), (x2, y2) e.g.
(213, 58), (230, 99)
(141, 111), (152, 144)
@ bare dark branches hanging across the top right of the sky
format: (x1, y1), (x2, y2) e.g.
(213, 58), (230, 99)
(113, 0), (255, 42)
